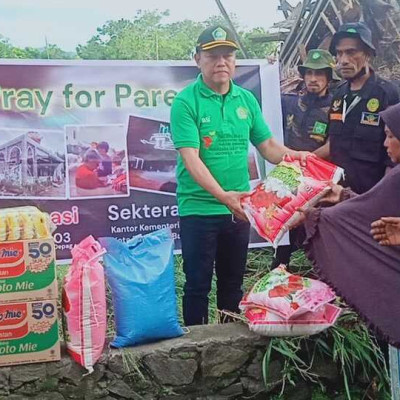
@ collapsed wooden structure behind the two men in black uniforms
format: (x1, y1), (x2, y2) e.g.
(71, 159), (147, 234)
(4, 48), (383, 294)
(253, 0), (400, 79)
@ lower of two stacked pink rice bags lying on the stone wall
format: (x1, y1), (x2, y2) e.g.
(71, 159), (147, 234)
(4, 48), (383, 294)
(245, 304), (341, 336)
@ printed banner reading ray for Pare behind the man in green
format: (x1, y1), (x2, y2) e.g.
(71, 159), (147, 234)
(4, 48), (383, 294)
(0, 60), (282, 261)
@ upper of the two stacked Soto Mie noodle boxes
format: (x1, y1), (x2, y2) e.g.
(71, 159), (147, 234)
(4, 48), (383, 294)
(0, 239), (57, 304)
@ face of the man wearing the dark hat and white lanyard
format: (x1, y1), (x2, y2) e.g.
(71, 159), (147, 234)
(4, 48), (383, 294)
(336, 38), (369, 79)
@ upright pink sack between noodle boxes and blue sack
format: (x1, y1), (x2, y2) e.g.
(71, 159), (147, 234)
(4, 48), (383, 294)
(62, 236), (107, 373)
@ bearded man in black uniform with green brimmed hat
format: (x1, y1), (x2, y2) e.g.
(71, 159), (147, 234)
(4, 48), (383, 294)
(272, 49), (338, 267)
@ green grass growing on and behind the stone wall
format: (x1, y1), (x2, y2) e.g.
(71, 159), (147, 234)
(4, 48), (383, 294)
(58, 249), (390, 400)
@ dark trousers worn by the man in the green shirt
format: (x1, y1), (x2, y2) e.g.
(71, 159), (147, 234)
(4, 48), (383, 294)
(180, 215), (250, 326)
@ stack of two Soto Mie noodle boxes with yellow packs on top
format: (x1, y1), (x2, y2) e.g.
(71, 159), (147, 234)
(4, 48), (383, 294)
(0, 207), (60, 366)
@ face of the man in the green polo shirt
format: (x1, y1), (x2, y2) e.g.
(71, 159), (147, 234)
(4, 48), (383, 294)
(195, 46), (236, 88)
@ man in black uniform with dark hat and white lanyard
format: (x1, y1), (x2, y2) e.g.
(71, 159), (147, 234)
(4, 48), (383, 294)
(320, 22), (399, 193)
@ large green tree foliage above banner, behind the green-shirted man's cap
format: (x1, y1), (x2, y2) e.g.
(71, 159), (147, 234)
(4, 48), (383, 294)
(77, 10), (275, 60)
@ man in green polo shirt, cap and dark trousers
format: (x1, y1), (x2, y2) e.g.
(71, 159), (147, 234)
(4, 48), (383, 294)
(171, 26), (306, 325)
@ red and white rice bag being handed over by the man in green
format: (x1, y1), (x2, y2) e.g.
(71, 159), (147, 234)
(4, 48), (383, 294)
(242, 156), (343, 247)
